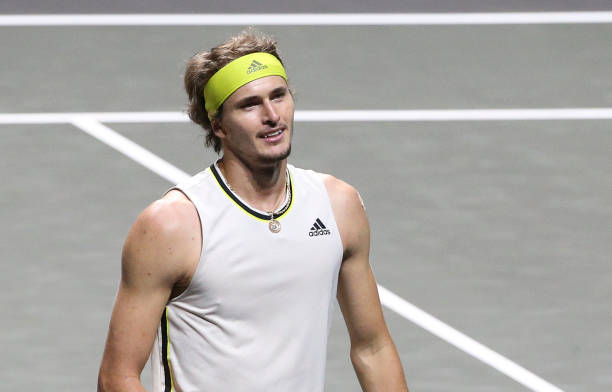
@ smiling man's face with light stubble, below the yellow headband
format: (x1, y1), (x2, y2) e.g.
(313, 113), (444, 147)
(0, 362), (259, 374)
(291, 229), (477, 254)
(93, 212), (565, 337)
(213, 76), (294, 166)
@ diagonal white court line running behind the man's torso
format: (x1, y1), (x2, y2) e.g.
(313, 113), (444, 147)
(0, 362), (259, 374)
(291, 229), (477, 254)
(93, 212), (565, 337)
(70, 116), (563, 392)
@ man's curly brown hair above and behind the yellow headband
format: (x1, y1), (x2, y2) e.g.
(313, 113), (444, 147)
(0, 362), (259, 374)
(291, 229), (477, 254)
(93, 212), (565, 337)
(184, 29), (283, 153)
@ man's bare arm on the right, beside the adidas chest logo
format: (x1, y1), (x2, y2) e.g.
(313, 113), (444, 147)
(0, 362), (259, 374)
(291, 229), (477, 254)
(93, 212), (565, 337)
(324, 176), (408, 392)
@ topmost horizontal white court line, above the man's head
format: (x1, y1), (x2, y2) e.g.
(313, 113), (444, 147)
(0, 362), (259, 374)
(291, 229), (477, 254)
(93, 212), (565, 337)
(0, 11), (612, 26)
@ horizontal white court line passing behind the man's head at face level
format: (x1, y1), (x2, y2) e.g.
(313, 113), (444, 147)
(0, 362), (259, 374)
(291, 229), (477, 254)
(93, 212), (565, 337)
(0, 108), (612, 124)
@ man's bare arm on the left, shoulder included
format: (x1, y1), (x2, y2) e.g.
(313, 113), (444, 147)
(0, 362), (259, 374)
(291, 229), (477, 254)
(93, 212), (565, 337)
(98, 192), (201, 392)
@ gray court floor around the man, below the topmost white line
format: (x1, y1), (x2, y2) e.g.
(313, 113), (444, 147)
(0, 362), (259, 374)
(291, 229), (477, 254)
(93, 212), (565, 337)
(0, 3), (612, 391)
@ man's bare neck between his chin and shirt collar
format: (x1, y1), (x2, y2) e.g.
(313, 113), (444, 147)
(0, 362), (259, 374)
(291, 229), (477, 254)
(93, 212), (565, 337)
(217, 155), (287, 211)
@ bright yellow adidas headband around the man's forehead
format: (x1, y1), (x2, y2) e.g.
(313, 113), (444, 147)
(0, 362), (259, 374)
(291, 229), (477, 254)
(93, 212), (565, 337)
(204, 52), (287, 118)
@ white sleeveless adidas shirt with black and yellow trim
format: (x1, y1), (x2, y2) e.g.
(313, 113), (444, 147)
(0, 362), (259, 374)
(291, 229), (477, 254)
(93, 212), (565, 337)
(151, 165), (343, 392)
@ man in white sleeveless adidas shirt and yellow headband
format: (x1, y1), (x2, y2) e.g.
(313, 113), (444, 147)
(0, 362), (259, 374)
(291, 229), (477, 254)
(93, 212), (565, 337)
(98, 32), (407, 392)
